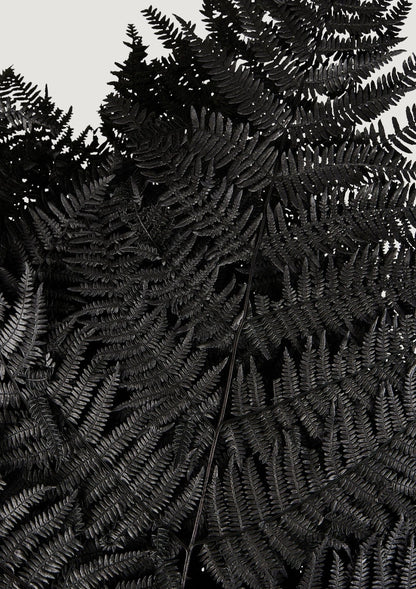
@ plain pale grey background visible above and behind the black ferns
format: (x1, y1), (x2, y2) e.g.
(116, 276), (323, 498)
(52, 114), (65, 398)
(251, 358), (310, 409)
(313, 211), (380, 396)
(0, 0), (416, 139)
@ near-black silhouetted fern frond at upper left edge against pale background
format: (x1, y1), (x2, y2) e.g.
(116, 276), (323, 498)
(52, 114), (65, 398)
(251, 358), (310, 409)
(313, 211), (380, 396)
(0, 68), (106, 223)
